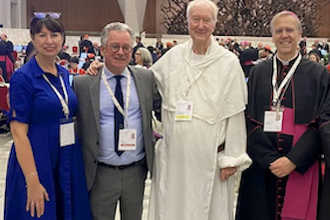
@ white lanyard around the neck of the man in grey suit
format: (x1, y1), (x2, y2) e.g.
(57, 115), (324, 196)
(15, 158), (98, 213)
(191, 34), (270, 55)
(102, 68), (131, 126)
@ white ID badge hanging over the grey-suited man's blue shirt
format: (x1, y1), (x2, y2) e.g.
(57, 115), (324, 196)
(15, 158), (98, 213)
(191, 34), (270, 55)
(118, 129), (136, 150)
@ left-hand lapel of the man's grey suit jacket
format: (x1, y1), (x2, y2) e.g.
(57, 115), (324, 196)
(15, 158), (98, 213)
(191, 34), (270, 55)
(89, 68), (103, 134)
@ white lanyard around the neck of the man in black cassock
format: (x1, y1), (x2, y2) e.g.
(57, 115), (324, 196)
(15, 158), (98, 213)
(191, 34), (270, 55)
(272, 53), (302, 107)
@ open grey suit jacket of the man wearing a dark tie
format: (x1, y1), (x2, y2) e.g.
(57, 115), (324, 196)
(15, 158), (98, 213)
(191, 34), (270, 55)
(73, 66), (161, 191)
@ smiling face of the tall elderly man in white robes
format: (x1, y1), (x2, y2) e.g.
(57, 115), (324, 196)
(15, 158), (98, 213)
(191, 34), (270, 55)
(188, 4), (216, 43)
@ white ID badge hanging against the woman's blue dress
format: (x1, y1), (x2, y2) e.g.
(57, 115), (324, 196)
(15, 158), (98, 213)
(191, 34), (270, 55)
(60, 117), (76, 147)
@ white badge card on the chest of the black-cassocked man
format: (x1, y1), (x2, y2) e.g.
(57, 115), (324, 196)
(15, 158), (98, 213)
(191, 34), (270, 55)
(264, 111), (283, 132)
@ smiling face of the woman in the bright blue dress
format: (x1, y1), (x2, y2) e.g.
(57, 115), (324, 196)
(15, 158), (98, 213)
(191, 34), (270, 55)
(31, 26), (64, 58)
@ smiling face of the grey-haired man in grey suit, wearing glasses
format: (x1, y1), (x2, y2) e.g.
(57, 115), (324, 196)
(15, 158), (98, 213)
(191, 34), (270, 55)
(101, 30), (132, 74)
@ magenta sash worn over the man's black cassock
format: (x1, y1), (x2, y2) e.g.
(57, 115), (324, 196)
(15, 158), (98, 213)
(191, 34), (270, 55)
(281, 108), (319, 220)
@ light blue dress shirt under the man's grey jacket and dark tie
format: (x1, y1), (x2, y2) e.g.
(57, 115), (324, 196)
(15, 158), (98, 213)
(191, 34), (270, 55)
(98, 66), (145, 166)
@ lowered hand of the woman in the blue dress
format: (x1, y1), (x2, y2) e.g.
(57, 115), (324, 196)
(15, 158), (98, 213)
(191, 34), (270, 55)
(26, 177), (49, 218)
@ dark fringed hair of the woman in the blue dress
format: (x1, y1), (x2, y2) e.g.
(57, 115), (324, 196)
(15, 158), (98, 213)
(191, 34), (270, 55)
(30, 15), (65, 45)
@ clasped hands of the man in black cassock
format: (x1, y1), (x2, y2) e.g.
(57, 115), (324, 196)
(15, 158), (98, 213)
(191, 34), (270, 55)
(269, 157), (297, 178)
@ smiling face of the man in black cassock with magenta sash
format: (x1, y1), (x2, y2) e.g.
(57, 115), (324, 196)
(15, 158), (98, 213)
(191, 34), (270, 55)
(272, 15), (301, 60)
